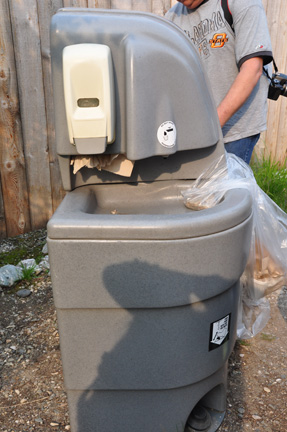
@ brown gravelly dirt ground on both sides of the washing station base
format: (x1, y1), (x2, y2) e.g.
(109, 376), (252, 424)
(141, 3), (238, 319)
(0, 233), (287, 432)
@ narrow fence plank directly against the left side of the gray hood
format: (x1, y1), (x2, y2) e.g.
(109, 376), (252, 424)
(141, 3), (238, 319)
(38, 0), (64, 211)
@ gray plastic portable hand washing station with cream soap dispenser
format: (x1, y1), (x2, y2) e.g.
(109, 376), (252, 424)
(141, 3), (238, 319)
(48, 8), (252, 432)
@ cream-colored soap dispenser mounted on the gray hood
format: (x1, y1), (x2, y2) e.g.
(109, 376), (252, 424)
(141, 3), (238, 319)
(63, 43), (115, 155)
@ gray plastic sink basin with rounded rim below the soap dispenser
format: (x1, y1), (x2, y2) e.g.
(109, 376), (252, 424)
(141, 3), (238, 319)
(48, 181), (252, 240)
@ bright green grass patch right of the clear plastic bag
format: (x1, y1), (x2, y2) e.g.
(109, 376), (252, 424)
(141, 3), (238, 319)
(250, 157), (287, 212)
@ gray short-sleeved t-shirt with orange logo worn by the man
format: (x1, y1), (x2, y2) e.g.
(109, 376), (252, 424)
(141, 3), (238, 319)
(166, 0), (272, 143)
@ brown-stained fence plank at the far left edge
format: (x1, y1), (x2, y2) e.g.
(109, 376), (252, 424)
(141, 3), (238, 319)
(0, 0), (30, 237)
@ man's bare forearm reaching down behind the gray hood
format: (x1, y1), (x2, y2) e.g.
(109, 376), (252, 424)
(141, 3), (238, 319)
(217, 57), (263, 127)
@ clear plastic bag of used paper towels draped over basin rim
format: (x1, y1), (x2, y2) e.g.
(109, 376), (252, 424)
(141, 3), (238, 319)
(182, 153), (287, 339)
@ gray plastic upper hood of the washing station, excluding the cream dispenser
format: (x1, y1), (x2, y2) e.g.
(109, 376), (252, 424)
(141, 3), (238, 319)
(51, 8), (223, 189)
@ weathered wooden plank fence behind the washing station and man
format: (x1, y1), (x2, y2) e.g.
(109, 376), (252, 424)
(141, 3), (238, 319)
(0, 0), (287, 238)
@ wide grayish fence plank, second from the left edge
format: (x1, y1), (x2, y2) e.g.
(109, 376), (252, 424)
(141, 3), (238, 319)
(9, 0), (52, 230)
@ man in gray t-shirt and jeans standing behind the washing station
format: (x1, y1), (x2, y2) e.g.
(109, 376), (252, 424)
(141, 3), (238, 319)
(165, 0), (273, 163)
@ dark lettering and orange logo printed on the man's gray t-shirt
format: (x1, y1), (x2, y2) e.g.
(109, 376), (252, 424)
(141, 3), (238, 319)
(185, 11), (228, 58)
